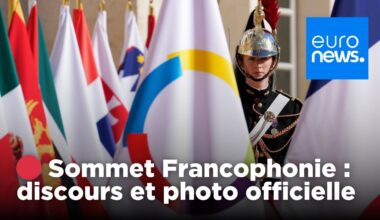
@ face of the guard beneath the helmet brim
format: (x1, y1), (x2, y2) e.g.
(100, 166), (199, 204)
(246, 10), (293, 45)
(242, 55), (273, 79)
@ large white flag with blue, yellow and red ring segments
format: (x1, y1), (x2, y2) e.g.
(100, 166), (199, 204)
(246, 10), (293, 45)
(119, 0), (263, 217)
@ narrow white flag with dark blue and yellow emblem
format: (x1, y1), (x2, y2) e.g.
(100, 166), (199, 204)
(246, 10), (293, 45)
(118, 10), (145, 110)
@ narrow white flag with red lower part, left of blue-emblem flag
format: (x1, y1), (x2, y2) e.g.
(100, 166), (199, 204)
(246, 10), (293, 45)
(92, 7), (128, 146)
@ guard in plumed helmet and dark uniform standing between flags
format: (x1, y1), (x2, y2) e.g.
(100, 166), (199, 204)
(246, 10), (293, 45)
(235, 0), (302, 175)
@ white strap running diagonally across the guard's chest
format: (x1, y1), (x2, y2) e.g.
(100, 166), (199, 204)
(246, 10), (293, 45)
(249, 94), (290, 146)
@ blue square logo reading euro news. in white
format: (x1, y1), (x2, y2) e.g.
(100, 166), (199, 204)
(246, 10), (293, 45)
(306, 17), (368, 80)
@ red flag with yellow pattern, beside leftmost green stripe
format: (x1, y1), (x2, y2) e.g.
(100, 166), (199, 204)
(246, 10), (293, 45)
(8, 0), (61, 187)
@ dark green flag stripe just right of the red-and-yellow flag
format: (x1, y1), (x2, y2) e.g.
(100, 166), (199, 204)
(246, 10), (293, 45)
(38, 18), (66, 138)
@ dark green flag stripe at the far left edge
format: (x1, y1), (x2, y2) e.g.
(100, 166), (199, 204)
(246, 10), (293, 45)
(0, 10), (19, 96)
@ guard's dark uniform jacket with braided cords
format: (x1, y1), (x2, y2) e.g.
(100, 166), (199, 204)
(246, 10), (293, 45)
(238, 72), (302, 165)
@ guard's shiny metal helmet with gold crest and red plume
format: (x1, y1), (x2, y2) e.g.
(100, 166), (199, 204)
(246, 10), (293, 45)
(236, 0), (280, 81)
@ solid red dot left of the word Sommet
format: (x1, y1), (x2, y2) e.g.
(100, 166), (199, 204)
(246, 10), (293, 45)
(16, 155), (41, 180)
